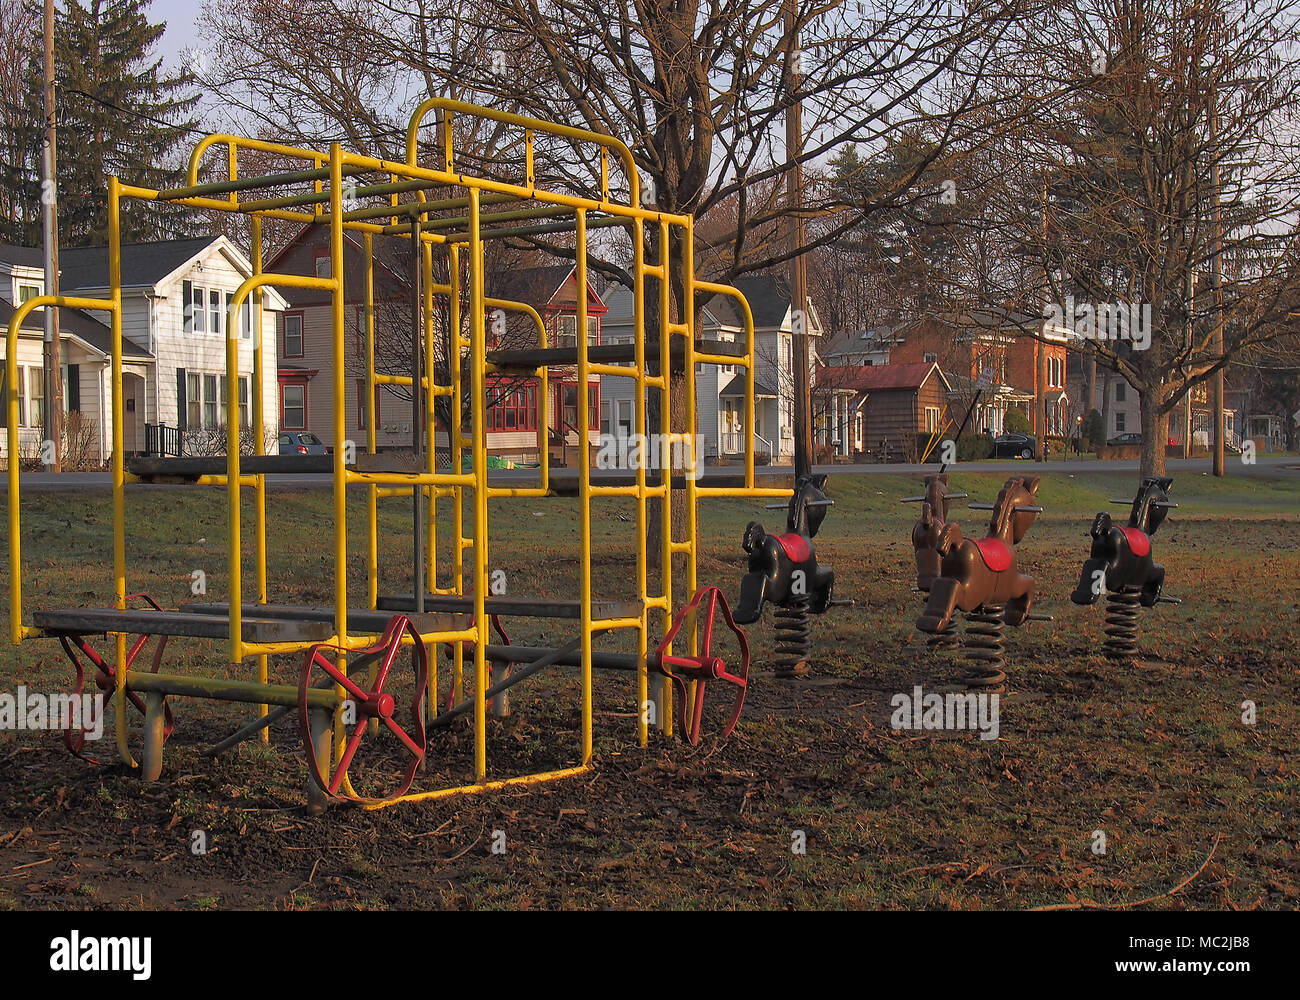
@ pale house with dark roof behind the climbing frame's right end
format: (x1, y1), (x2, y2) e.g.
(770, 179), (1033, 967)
(601, 274), (822, 464)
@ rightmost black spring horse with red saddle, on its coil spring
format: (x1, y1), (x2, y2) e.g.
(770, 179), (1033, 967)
(1070, 476), (1180, 659)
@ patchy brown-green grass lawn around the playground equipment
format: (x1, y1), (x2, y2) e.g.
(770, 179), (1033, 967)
(0, 463), (1300, 909)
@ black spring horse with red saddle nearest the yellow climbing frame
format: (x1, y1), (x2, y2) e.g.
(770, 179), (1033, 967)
(736, 475), (852, 678)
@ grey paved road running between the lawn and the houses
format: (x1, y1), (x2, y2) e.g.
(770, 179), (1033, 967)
(0, 455), (1300, 494)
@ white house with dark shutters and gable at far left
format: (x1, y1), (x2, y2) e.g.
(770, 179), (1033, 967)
(0, 237), (286, 463)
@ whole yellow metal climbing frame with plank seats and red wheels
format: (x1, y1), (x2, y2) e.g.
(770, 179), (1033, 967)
(7, 98), (790, 809)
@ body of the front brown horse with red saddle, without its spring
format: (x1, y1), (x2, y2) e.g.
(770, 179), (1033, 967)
(917, 476), (1043, 632)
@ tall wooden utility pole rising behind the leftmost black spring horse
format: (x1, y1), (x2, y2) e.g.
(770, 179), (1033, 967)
(777, 0), (813, 479)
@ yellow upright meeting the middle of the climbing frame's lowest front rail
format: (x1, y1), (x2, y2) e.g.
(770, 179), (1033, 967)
(467, 187), (488, 782)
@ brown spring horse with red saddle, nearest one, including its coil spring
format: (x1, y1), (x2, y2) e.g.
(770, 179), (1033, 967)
(917, 476), (1050, 692)
